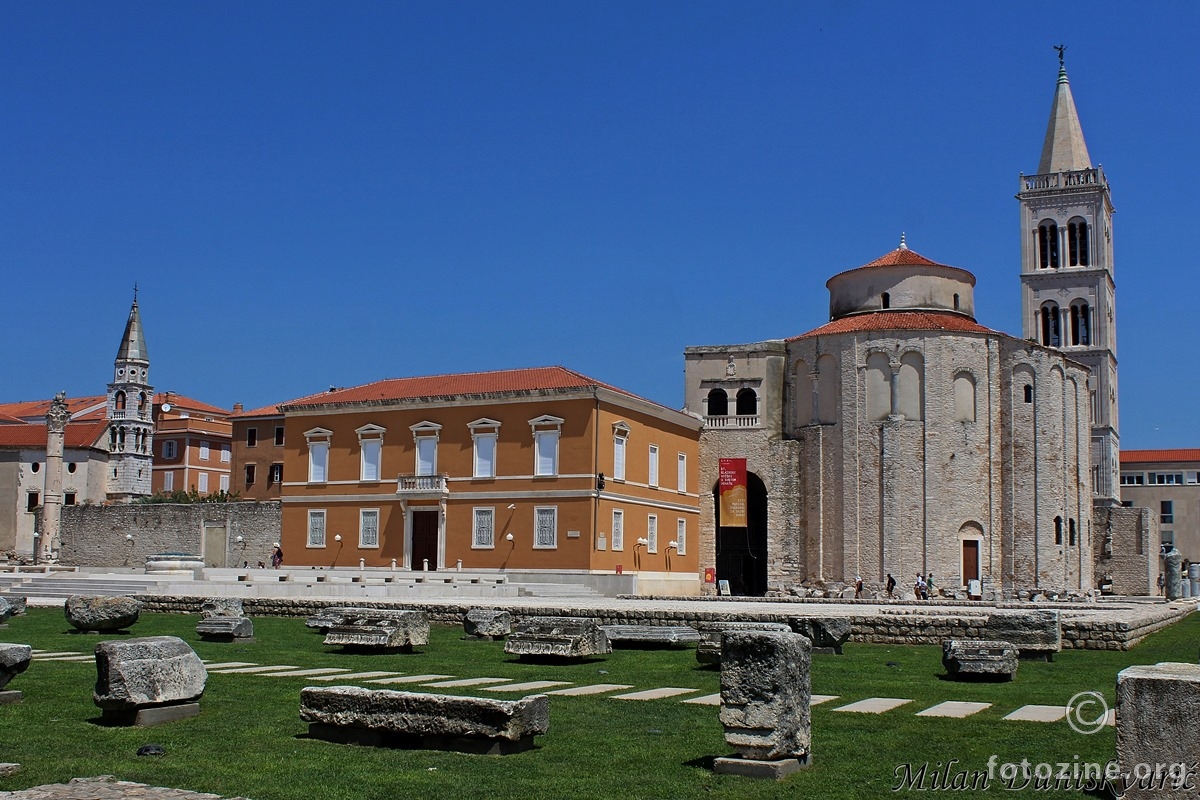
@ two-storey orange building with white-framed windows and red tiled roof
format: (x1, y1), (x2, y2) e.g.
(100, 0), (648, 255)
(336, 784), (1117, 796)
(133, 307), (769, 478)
(280, 367), (701, 594)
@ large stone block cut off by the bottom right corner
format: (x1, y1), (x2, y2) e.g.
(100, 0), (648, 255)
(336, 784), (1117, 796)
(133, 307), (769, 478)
(1117, 662), (1200, 800)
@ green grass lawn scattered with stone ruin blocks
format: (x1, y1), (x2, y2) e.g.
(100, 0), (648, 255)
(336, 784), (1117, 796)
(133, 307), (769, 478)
(0, 608), (1200, 800)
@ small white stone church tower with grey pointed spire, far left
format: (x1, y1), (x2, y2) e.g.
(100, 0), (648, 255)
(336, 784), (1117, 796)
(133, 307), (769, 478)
(108, 288), (154, 503)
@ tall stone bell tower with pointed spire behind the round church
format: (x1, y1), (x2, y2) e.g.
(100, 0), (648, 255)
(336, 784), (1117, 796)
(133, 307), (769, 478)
(1016, 46), (1121, 506)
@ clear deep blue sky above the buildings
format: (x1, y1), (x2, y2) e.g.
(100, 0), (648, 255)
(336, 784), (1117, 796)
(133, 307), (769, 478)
(0, 0), (1200, 447)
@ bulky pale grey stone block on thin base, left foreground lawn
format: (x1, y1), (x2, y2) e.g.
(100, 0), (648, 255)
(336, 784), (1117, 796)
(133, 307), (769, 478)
(92, 636), (209, 726)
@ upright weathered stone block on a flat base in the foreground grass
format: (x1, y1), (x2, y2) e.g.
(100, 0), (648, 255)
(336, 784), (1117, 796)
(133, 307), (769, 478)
(714, 630), (812, 778)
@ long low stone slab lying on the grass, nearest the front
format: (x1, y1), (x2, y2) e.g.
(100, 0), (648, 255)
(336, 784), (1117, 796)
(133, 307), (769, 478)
(300, 686), (550, 754)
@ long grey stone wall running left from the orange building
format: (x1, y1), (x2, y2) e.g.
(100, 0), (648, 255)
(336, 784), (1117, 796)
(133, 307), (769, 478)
(59, 503), (286, 567)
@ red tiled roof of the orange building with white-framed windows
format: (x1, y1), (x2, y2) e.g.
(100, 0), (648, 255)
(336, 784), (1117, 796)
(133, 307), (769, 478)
(282, 367), (658, 409)
